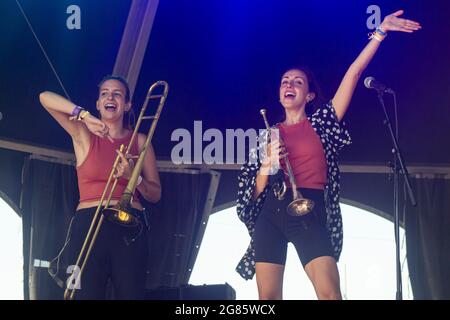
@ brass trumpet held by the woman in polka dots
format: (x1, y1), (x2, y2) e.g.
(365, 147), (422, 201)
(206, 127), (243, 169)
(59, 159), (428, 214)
(259, 109), (315, 216)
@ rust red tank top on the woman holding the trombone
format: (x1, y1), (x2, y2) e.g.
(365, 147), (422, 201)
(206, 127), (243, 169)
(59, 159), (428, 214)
(77, 131), (139, 202)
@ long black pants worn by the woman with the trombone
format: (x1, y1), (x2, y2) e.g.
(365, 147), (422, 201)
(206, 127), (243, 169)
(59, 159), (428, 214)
(66, 208), (148, 300)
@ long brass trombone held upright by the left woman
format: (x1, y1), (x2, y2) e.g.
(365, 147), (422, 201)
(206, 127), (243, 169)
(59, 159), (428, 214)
(64, 81), (169, 300)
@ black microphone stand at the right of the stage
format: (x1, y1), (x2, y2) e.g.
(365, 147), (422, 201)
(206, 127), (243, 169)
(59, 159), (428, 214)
(378, 89), (417, 300)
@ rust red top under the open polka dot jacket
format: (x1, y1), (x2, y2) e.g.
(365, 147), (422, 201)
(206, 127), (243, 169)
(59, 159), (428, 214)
(278, 118), (327, 190)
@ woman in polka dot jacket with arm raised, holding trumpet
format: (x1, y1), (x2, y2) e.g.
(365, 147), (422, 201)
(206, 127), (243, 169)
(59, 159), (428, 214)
(236, 10), (421, 299)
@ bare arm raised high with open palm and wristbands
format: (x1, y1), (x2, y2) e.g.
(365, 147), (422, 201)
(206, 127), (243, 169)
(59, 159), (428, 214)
(332, 10), (421, 121)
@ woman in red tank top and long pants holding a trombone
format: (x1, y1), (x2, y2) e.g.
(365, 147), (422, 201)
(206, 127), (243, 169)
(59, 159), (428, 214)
(39, 76), (161, 299)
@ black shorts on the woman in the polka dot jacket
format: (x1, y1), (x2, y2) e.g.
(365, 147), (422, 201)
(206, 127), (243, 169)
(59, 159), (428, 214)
(253, 188), (333, 267)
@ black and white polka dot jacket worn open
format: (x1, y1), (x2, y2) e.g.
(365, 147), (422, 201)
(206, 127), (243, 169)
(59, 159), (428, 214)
(236, 101), (351, 280)
